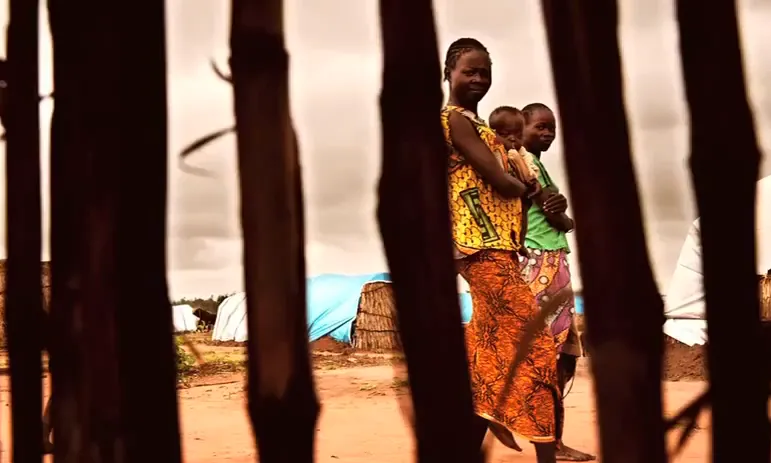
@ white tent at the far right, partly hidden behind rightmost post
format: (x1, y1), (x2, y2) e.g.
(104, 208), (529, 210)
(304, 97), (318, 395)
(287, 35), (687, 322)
(664, 176), (771, 346)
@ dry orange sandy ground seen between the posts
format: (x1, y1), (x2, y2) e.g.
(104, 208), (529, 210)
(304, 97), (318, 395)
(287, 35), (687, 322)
(0, 346), (709, 463)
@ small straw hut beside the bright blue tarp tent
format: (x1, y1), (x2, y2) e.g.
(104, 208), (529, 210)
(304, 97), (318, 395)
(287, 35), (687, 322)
(351, 281), (402, 351)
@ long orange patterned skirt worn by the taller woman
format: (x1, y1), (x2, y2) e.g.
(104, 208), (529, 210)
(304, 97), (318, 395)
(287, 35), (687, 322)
(458, 250), (562, 442)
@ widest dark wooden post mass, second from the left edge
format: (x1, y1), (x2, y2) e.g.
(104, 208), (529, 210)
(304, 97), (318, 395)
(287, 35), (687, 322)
(49, 0), (181, 462)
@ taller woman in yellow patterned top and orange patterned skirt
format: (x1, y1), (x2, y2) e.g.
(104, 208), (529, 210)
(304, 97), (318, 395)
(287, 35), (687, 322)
(442, 38), (561, 463)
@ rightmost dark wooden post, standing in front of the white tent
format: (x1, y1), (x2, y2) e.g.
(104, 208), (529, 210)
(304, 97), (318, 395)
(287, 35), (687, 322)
(677, 0), (771, 463)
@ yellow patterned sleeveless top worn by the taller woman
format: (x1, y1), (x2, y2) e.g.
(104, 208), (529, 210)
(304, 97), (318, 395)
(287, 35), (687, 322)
(442, 105), (522, 255)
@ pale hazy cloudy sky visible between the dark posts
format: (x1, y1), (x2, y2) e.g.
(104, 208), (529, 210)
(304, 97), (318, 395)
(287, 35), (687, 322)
(0, 0), (771, 299)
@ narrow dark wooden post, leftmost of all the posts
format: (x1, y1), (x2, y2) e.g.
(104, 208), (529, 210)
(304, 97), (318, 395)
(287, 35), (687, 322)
(3, 0), (43, 463)
